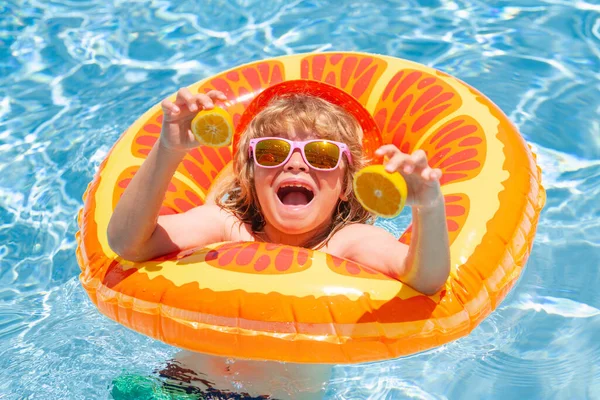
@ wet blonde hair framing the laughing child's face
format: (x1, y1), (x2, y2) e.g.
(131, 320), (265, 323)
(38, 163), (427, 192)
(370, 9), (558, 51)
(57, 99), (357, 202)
(216, 94), (373, 249)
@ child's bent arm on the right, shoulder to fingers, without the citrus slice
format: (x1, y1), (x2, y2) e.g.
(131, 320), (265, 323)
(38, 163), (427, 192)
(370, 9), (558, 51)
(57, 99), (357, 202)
(332, 145), (450, 295)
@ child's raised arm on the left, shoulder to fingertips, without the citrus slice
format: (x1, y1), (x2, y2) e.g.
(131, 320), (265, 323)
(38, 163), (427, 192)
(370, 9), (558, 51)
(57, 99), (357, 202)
(107, 89), (226, 261)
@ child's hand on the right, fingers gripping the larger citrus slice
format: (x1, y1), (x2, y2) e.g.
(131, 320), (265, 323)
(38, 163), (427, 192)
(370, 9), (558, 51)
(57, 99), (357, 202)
(375, 144), (442, 207)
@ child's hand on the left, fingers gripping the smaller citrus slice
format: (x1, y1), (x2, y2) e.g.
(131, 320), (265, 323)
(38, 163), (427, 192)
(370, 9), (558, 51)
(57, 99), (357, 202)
(160, 88), (227, 151)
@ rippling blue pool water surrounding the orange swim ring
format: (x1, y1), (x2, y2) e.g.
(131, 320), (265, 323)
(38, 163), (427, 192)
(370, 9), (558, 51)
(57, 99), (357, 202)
(0, 0), (600, 399)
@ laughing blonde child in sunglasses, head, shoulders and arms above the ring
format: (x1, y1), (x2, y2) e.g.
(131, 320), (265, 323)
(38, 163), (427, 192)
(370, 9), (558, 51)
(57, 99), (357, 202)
(108, 84), (450, 295)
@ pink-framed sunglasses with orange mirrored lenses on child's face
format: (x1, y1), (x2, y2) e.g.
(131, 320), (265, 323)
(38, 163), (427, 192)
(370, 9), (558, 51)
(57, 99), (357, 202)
(249, 137), (352, 171)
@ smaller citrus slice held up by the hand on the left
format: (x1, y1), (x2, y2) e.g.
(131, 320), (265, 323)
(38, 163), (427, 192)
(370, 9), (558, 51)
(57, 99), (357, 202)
(192, 107), (233, 147)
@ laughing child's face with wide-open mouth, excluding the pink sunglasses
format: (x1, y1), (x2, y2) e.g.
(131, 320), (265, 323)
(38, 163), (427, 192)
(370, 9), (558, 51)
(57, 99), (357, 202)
(254, 129), (347, 235)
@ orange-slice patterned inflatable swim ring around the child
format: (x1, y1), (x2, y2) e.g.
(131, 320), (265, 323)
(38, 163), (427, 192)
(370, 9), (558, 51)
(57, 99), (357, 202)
(77, 53), (545, 363)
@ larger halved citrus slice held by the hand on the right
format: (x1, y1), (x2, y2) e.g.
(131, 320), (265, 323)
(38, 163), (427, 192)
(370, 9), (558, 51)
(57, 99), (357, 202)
(353, 165), (408, 218)
